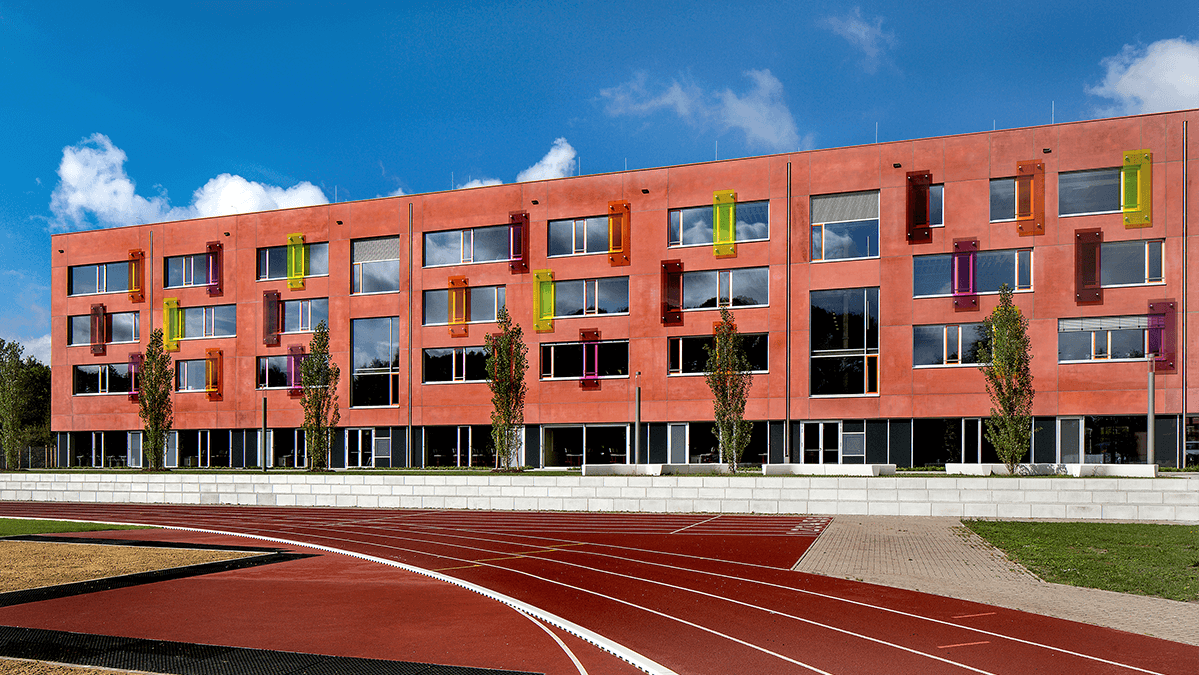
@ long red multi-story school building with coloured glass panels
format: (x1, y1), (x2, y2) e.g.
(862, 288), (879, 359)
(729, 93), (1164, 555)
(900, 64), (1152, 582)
(53, 110), (1199, 468)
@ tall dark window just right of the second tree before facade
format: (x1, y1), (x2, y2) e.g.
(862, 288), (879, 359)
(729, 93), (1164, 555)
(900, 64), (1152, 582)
(350, 317), (400, 408)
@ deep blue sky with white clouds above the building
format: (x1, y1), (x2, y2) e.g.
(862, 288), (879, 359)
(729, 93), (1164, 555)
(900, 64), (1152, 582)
(0, 0), (1199, 361)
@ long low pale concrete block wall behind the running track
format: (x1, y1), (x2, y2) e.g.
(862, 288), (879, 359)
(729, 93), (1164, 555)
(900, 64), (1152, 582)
(0, 472), (1199, 523)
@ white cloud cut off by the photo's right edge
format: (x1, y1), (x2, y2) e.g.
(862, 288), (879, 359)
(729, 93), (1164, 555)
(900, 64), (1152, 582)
(1086, 37), (1199, 115)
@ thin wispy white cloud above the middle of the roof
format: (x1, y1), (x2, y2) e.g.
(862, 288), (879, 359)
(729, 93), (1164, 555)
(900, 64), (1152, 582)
(600, 70), (813, 151)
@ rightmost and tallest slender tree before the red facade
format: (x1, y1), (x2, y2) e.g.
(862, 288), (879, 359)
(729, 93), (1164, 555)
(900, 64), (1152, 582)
(978, 284), (1036, 474)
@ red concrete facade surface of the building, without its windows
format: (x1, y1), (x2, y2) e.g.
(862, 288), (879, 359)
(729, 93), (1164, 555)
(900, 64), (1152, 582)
(52, 110), (1199, 464)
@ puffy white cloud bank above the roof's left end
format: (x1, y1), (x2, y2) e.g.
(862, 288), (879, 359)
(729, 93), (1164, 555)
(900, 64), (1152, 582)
(50, 133), (329, 230)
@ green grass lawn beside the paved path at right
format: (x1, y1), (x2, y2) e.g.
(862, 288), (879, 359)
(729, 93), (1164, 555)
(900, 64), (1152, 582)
(963, 520), (1199, 602)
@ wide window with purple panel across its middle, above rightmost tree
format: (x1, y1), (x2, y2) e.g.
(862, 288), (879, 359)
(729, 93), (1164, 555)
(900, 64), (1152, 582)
(911, 248), (1032, 297)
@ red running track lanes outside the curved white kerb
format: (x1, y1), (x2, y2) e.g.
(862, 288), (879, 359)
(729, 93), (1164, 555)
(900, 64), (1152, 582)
(0, 502), (1199, 675)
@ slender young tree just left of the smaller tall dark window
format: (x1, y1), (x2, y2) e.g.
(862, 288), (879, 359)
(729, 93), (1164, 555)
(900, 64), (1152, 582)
(300, 321), (342, 471)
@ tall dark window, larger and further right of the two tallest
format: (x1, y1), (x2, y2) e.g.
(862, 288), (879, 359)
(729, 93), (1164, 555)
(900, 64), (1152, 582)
(811, 288), (879, 396)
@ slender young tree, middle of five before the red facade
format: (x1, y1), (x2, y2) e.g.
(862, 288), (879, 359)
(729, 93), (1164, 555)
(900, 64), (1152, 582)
(486, 308), (529, 469)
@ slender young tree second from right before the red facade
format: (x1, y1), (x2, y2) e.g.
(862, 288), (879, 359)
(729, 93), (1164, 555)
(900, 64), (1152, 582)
(704, 307), (753, 474)
